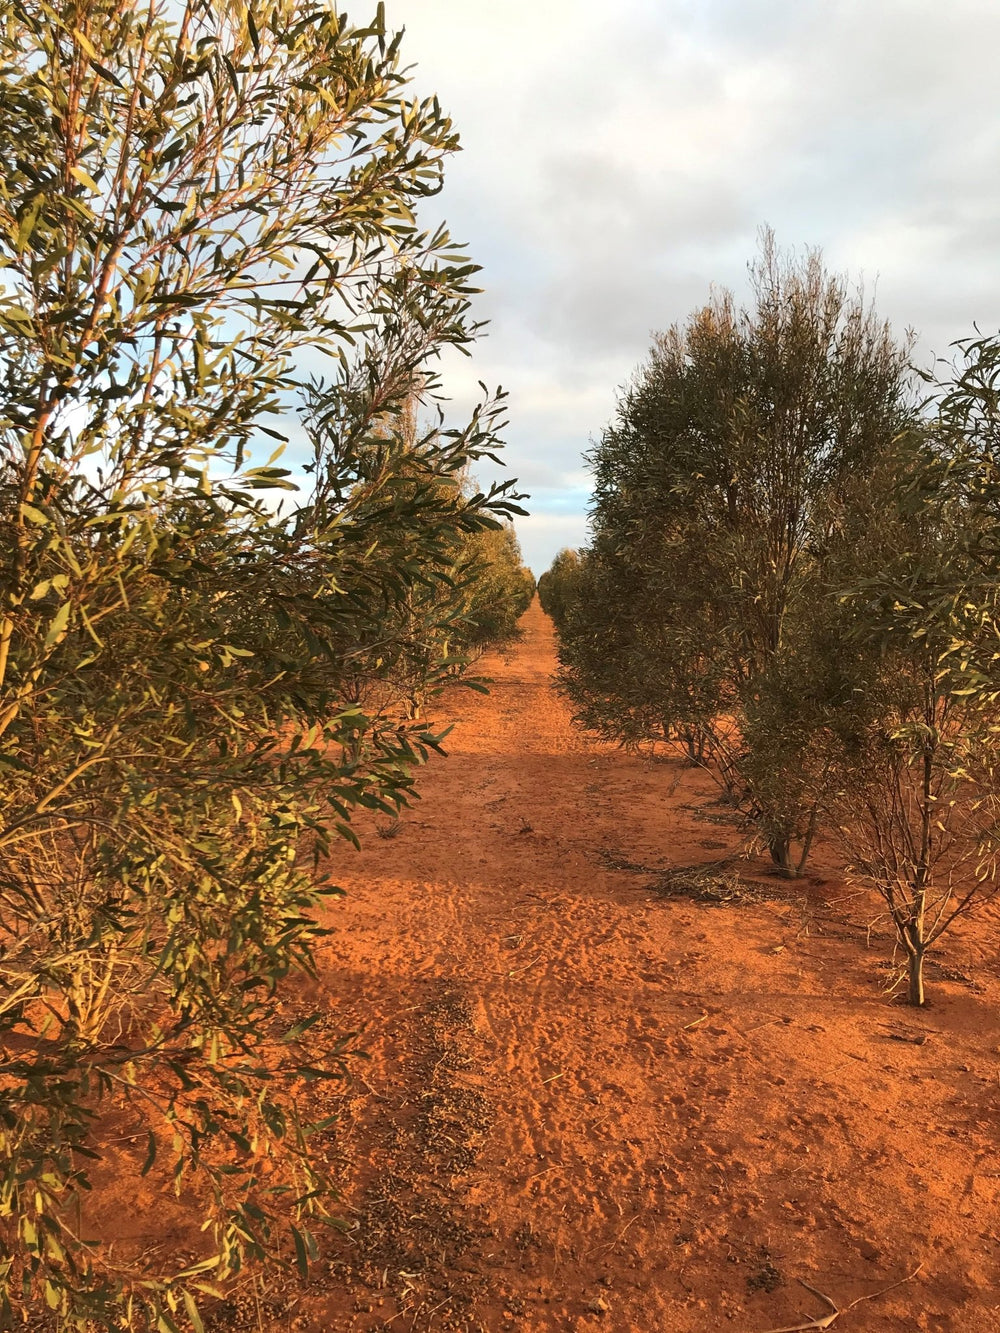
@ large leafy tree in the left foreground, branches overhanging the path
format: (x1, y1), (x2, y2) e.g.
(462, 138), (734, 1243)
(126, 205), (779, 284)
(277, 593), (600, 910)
(0, 0), (519, 1330)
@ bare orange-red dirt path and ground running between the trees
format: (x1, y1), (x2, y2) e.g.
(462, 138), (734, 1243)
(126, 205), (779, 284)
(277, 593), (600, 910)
(233, 604), (1000, 1333)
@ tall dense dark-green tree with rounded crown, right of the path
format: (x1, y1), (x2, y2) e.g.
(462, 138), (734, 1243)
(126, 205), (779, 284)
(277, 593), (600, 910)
(561, 235), (912, 873)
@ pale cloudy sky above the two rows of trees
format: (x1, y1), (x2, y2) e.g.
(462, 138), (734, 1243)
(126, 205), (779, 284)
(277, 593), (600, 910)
(384, 0), (1000, 573)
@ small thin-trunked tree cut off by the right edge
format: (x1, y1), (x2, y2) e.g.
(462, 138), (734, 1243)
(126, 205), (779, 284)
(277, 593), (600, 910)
(829, 354), (1000, 1005)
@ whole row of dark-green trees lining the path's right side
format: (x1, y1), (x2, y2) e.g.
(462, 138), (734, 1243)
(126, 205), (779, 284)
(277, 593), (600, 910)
(539, 233), (1000, 1004)
